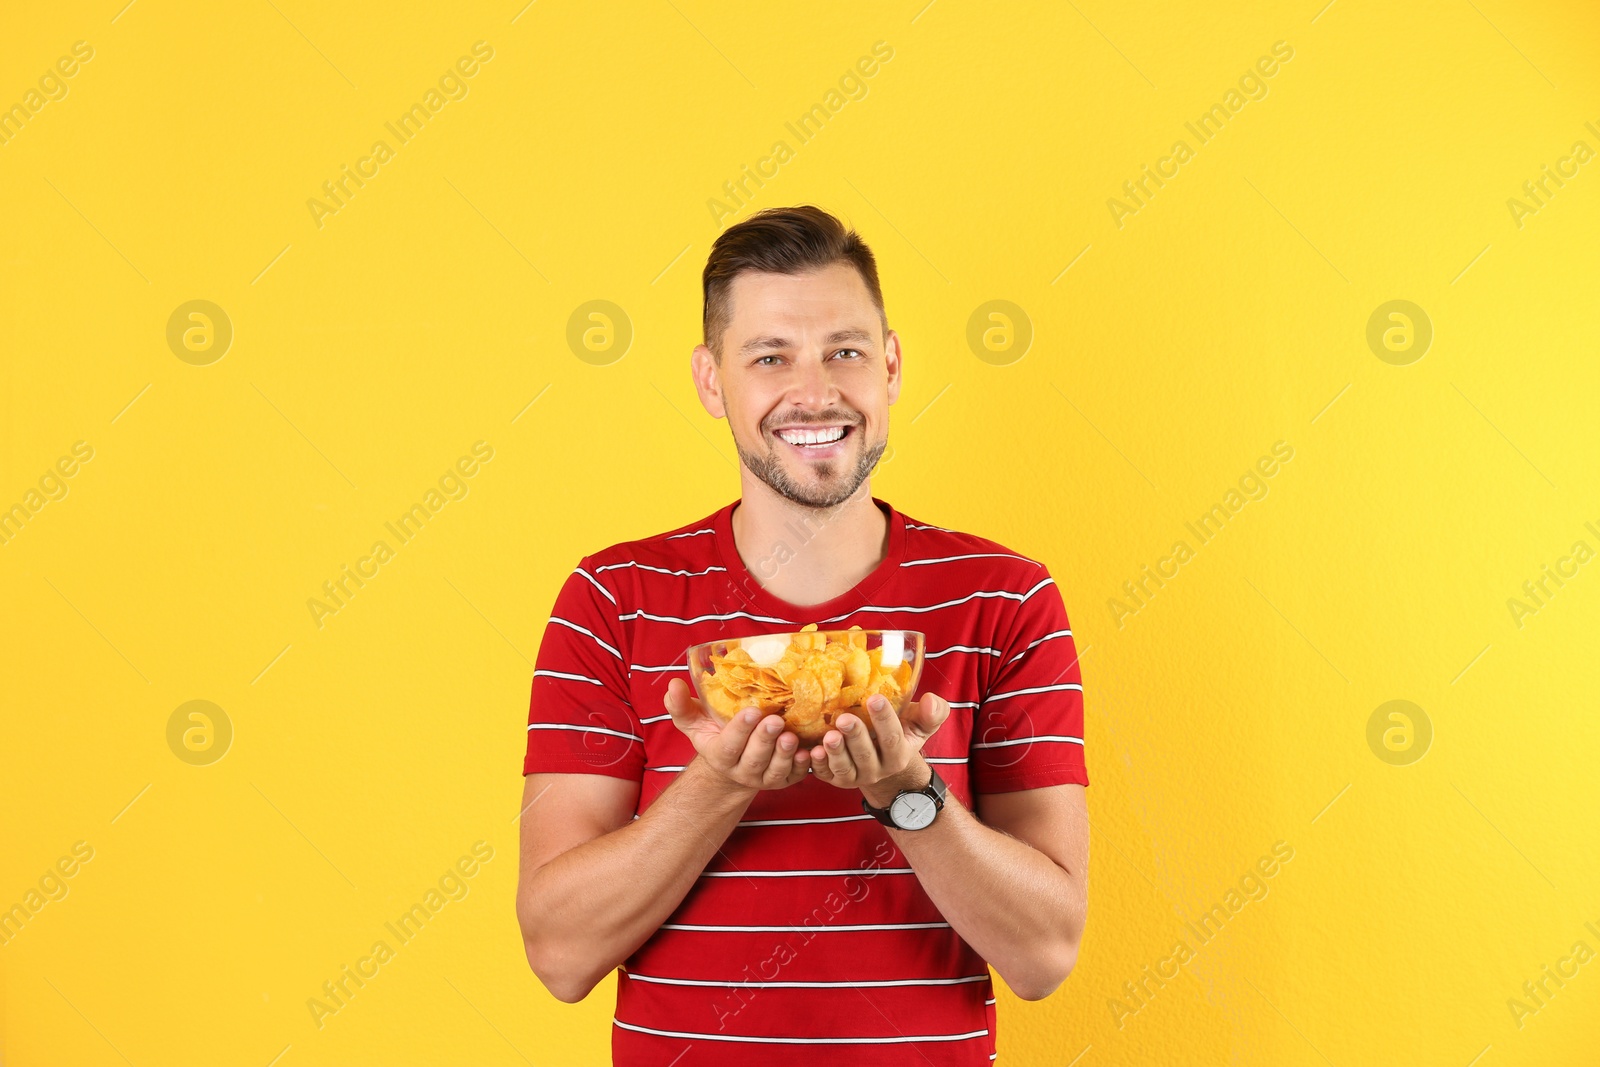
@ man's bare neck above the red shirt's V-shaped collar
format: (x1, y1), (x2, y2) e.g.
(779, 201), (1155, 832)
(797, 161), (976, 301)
(733, 475), (888, 608)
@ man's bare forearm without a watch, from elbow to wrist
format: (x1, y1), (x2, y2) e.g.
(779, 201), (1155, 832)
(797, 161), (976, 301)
(517, 757), (757, 1001)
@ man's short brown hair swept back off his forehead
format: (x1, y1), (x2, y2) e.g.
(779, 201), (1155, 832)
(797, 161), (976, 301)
(701, 203), (888, 365)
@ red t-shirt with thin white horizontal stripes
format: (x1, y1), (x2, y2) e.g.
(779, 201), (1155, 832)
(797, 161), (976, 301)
(523, 498), (1088, 1067)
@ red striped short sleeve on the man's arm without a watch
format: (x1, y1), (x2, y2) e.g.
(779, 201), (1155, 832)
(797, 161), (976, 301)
(522, 557), (645, 781)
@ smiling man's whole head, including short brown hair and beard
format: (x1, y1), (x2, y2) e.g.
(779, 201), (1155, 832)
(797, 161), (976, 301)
(693, 205), (901, 507)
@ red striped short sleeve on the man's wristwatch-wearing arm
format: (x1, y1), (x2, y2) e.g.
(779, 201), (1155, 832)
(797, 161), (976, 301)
(970, 566), (1090, 793)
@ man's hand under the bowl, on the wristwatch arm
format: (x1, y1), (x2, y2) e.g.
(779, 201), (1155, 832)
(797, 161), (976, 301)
(811, 693), (950, 808)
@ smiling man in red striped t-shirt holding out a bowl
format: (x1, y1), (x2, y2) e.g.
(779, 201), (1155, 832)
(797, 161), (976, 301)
(517, 206), (1090, 1067)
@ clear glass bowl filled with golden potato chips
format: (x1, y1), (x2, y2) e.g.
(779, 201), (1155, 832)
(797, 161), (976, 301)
(686, 622), (925, 745)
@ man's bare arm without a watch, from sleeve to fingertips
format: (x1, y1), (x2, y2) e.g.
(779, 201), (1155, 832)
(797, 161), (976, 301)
(517, 678), (808, 1003)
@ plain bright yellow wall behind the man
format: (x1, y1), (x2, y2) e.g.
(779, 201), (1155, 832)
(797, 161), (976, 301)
(0, 0), (1600, 1067)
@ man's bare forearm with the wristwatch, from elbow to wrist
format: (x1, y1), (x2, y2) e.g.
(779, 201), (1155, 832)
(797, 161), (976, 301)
(862, 757), (1088, 1000)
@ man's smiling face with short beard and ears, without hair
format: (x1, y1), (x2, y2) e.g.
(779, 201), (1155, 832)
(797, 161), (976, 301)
(693, 264), (901, 507)
